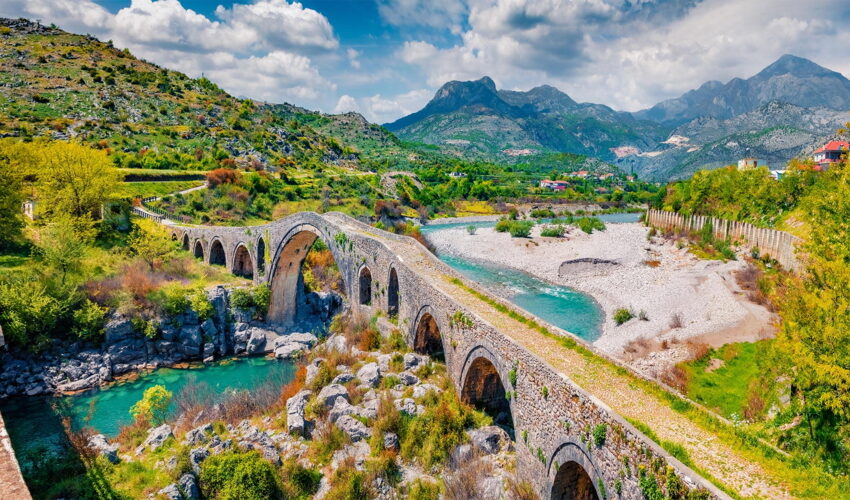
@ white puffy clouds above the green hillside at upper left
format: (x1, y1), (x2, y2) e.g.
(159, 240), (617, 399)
(0, 0), (339, 106)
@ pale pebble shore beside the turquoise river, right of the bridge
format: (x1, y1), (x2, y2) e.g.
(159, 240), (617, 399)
(428, 219), (772, 365)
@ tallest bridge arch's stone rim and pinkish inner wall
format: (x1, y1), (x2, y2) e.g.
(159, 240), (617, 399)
(267, 224), (348, 325)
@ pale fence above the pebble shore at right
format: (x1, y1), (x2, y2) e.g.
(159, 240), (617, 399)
(646, 209), (802, 272)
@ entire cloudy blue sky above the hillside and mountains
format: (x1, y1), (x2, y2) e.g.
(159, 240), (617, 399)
(0, 0), (850, 123)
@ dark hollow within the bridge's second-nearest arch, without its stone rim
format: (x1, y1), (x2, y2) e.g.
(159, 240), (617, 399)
(461, 356), (514, 437)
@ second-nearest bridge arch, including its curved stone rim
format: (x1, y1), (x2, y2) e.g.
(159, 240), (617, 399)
(460, 345), (514, 437)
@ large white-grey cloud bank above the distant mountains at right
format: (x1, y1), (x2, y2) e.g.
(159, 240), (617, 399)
(397, 0), (850, 110)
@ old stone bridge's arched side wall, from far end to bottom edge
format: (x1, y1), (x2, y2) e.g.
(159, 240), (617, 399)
(165, 212), (727, 499)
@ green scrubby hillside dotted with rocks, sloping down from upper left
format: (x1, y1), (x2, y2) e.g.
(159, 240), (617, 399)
(0, 19), (402, 173)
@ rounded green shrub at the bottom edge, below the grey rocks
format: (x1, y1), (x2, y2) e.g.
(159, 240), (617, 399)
(200, 451), (283, 500)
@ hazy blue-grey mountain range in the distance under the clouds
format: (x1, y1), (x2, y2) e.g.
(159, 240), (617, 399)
(385, 55), (850, 180)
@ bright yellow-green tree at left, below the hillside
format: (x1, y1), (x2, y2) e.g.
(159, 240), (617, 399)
(29, 141), (120, 219)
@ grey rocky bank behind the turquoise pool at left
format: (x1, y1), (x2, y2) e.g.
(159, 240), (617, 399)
(0, 286), (343, 398)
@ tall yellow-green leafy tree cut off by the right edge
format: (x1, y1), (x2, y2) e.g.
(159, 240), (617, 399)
(778, 140), (850, 466)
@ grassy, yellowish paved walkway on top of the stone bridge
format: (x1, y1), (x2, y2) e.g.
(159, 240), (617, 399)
(329, 214), (793, 499)
